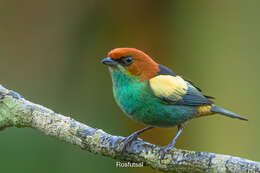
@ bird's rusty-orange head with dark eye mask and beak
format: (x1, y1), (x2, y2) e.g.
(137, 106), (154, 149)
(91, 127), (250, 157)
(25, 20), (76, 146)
(102, 48), (160, 81)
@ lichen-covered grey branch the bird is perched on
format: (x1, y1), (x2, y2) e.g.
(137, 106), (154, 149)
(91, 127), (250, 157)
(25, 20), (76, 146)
(0, 85), (260, 173)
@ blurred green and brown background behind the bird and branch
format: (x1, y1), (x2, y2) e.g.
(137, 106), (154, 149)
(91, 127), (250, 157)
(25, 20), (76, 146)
(0, 0), (260, 173)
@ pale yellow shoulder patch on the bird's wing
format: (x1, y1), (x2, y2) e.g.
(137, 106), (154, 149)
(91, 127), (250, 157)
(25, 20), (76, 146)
(150, 75), (188, 101)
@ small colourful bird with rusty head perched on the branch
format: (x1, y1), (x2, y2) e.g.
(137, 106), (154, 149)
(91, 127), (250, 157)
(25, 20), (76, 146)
(102, 48), (247, 154)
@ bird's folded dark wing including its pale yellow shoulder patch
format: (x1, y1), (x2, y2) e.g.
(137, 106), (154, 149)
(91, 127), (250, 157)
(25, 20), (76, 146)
(149, 65), (213, 106)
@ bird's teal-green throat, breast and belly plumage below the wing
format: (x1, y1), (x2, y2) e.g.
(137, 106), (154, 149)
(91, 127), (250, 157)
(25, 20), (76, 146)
(111, 70), (197, 127)
